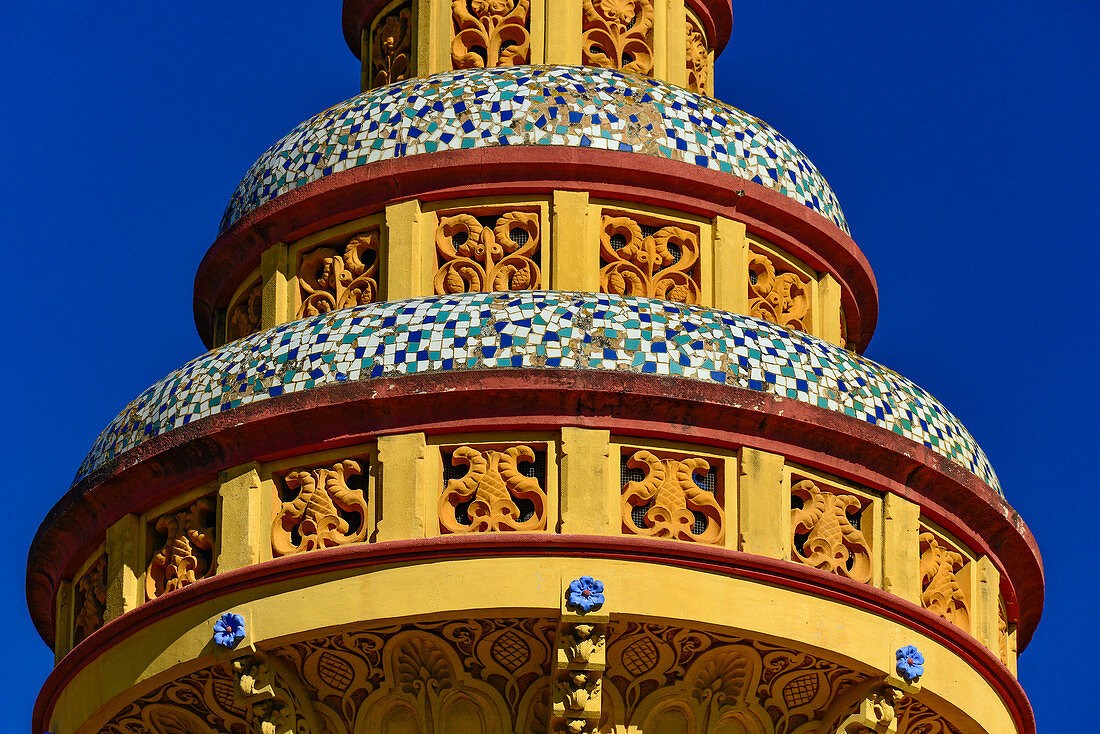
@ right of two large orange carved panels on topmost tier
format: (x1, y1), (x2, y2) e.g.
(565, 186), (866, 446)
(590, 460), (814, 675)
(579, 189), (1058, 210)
(581, 0), (653, 76)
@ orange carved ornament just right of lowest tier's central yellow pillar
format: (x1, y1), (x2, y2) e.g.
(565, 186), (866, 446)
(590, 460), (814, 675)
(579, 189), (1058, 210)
(620, 451), (726, 544)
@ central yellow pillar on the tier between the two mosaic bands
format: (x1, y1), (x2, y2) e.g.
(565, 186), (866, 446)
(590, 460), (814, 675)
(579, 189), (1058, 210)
(550, 191), (600, 293)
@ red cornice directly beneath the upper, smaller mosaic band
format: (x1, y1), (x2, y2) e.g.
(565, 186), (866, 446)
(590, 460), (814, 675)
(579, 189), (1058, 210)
(194, 145), (879, 351)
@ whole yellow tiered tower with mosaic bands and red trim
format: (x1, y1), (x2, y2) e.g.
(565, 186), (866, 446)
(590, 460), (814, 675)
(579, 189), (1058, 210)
(29, 0), (1042, 734)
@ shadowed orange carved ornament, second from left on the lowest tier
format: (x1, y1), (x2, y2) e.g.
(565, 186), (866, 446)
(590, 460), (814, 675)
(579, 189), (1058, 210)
(145, 497), (218, 599)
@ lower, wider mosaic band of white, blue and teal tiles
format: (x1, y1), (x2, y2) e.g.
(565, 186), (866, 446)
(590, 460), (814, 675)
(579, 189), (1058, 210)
(76, 292), (1000, 493)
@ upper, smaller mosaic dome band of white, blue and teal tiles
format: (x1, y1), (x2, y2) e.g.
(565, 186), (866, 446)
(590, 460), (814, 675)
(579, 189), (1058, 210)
(220, 66), (848, 232)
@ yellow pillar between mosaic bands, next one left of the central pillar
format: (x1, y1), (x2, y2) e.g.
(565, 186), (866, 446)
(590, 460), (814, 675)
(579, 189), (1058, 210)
(382, 199), (424, 300)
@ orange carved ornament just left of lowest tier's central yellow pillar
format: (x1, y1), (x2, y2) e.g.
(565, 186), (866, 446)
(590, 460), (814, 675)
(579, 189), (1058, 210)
(439, 446), (547, 533)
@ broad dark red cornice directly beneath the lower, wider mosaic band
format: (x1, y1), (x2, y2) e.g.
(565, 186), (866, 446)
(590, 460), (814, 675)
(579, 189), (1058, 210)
(26, 369), (1044, 650)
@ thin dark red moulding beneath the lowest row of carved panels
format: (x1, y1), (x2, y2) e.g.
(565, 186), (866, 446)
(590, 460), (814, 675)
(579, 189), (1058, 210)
(32, 533), (1035, 734)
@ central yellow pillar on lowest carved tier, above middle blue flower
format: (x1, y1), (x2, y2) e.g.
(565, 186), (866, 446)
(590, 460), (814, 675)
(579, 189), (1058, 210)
(559, 427), (618, 535)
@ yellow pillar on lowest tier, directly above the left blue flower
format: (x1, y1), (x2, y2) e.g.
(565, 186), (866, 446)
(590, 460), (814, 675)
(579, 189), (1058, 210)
(218, 461), (271, 573)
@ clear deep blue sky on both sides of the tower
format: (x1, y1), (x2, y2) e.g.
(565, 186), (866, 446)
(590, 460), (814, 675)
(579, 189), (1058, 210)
(0, 0), (1100, 731)
